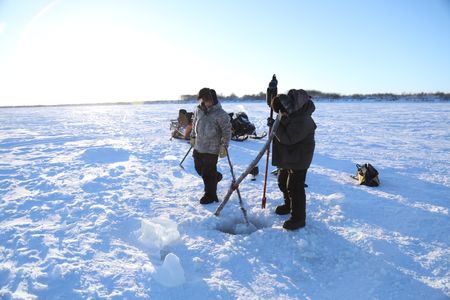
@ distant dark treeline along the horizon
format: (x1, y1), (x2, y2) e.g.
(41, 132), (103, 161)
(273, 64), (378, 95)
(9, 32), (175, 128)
(180, 90), (450, 101)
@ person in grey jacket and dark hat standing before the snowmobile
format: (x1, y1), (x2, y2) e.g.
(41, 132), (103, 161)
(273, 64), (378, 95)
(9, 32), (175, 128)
(191, 88), (231, 204)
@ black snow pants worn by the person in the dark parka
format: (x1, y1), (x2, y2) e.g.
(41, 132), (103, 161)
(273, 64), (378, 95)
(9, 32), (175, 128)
(278, 169), (307, 221)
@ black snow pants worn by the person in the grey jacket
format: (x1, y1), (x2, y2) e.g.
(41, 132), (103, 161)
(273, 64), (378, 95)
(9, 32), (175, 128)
(193, 150), (222, 199)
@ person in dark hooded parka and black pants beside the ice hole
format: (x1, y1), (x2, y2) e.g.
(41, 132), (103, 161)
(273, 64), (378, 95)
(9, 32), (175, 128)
(272, 90), (317, 230)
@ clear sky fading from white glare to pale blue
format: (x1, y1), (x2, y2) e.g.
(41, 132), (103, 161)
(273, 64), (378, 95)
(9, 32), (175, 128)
(0, 0), (450, 105)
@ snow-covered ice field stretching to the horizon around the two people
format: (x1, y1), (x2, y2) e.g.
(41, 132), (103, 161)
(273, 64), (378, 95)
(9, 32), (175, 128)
(0, 102), (450, 299)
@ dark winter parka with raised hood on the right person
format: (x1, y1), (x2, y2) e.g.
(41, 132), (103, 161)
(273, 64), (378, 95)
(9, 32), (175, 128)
(272, 90), (317, 170)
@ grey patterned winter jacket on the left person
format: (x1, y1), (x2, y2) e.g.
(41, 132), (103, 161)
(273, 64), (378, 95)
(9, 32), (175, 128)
(191, 103), (231, 155)
